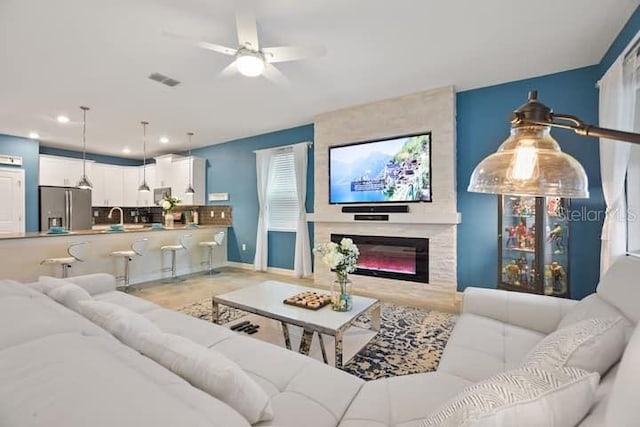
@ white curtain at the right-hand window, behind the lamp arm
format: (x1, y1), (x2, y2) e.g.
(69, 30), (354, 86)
(599, 57), (633, 276)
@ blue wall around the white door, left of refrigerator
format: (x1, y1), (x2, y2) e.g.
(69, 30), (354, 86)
(0, 135), (40, 231)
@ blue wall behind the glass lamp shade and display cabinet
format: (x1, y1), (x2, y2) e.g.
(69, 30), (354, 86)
(456, 66), (605, 299)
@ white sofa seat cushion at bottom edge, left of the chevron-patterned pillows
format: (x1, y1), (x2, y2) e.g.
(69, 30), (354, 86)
(340, 372), (472, 427)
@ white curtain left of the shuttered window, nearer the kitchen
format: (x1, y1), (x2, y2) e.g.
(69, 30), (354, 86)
(253, 150), (272, 271)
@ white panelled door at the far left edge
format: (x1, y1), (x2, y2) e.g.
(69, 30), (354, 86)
(0, 168), (25, 233)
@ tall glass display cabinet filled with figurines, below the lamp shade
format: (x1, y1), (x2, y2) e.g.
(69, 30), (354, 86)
(498, 195), (569, 297)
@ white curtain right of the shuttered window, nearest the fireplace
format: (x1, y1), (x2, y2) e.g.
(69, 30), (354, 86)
(293, 142), (311, 277)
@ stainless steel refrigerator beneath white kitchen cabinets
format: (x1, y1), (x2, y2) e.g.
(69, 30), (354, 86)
(40, 185), (91, 231)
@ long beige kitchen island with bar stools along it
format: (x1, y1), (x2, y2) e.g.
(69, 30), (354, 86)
(0, 224), (227, 284)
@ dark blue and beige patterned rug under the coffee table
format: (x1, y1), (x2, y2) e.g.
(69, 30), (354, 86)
(178, 299), (456, 381)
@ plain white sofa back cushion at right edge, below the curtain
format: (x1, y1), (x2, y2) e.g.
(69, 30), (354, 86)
(596, 256), (640, 324)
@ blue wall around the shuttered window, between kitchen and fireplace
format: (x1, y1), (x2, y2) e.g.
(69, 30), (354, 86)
(193, 125), (314, 269)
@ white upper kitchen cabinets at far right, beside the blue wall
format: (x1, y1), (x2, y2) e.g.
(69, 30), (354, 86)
(156, 154), (205, 205)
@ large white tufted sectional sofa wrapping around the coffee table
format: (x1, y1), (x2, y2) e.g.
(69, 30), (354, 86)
(0, 258), (640, 427)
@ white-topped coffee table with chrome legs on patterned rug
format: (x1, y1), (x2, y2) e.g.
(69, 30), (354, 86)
(212, 280), (380, 368)
